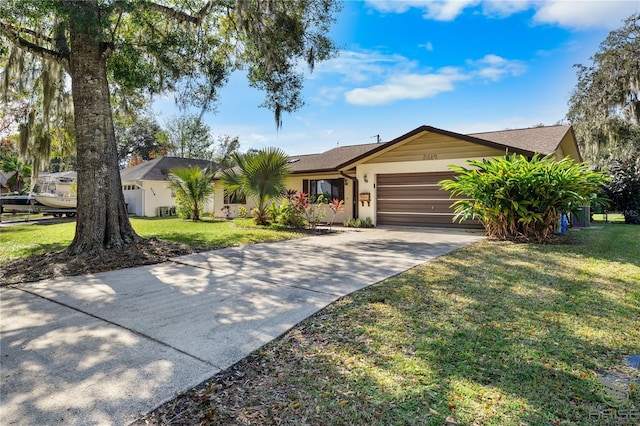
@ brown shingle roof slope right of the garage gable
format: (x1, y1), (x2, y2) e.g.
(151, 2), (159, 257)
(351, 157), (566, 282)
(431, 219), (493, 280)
(467, 125), (571, 155)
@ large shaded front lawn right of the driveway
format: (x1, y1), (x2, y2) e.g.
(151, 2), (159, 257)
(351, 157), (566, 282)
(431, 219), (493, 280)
(144, 224), (640, 425)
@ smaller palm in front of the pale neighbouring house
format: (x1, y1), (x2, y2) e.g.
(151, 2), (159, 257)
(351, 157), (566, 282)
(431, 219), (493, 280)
(169, 166), (215, 220)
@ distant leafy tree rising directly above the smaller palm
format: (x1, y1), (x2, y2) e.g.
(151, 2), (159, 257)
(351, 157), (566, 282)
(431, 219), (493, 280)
(167, 115), (213, 160)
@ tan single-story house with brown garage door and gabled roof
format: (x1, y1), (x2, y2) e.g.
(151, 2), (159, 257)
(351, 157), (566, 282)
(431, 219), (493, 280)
(214, 125), (582, 227)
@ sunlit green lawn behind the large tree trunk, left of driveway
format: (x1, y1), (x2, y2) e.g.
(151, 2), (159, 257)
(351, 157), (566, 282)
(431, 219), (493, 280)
(0, 217), (301, 265)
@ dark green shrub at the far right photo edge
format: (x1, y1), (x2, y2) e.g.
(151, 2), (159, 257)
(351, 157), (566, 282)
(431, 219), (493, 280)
(604, 155), (640, 224)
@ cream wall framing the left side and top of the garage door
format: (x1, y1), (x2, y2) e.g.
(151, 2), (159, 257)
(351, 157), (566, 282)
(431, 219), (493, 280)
(356, 157), (493, 225)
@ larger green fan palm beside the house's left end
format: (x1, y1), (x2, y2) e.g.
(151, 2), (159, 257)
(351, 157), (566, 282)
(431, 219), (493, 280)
(220, 148), (289, 225)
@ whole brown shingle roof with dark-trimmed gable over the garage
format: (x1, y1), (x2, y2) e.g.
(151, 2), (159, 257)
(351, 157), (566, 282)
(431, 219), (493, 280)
(290, 125), (573, 173)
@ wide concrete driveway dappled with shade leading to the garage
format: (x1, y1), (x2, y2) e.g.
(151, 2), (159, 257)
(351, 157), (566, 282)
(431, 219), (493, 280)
(0, 228), (483, 425)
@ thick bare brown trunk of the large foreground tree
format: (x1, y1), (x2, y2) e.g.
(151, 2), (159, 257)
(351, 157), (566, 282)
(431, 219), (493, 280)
(67, 2), (140, 255)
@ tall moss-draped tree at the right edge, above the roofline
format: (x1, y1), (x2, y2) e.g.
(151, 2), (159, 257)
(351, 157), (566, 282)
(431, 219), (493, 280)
(567, 13), (640, 168)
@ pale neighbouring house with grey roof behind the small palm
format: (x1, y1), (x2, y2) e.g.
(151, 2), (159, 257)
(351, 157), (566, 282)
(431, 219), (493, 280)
(120, 157), (220, 217)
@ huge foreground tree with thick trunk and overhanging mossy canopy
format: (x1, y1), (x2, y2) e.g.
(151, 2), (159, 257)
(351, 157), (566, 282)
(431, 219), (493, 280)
(0, 0), (337, 258)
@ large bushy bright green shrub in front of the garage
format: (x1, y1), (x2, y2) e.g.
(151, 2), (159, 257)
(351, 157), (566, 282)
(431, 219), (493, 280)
(440, 154), (606, 243)
